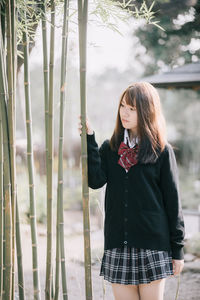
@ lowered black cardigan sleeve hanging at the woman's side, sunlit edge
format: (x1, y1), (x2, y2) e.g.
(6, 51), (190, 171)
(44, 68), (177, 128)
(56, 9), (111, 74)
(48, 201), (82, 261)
(160, 144), (185, 259)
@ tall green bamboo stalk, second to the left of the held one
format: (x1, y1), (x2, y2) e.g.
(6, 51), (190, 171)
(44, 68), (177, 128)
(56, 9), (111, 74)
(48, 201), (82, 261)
(45, 0), (55, 299)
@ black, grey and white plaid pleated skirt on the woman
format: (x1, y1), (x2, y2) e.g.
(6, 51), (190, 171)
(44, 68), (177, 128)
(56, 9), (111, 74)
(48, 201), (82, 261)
(99, 246), (174, 285)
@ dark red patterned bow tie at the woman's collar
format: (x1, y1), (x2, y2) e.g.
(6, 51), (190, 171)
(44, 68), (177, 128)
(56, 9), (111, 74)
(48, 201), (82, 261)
(118, 142), (138, 171)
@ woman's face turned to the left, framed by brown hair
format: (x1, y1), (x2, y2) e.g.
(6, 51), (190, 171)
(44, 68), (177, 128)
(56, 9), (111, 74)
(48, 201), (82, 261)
(119, 98), (137, 131)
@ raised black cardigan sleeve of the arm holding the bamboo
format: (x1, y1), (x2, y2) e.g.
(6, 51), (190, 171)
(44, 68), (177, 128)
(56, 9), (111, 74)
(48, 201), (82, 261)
(87, 132), (108, 189)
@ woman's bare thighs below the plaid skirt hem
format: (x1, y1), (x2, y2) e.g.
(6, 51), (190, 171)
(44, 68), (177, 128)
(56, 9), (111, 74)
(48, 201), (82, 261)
(112, 278), (166, 300)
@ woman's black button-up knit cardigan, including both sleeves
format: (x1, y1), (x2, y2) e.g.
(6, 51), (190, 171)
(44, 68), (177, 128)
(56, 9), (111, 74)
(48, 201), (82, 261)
(87, 132), (185, 259)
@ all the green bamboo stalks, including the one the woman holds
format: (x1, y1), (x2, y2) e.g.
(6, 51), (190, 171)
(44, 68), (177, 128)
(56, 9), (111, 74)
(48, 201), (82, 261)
(0, 0), (157, 300)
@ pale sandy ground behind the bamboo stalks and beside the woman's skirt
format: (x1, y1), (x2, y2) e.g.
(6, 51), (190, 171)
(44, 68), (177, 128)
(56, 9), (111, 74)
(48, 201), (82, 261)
(16, 211), (200, 300)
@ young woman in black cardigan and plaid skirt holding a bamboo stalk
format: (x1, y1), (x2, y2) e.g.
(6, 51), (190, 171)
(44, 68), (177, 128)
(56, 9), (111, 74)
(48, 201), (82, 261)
(79, 82), (185, 300)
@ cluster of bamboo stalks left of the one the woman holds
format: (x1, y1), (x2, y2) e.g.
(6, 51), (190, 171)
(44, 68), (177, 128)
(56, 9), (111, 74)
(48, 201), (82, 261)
(0, 0), (72, 300)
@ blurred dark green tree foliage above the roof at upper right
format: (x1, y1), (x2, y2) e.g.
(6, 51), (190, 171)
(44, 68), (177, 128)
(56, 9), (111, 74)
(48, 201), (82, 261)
(126, 0), (200, 75)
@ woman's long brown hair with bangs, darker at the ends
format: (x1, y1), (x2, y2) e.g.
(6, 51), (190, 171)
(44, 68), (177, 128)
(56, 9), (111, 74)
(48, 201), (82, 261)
(110, 82), (167, 163)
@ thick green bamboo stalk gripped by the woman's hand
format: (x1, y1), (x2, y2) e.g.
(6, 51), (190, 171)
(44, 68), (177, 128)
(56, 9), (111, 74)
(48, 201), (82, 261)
(78, 0), (92, 300)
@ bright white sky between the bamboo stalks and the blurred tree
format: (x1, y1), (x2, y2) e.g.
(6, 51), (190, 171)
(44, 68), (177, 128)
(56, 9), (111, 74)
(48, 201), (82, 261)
(30, 1), (144, 76)
